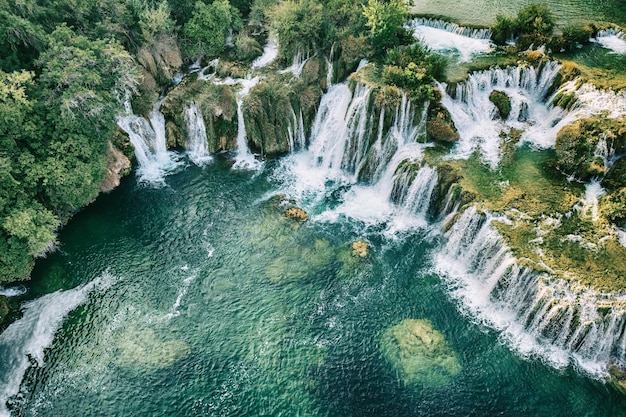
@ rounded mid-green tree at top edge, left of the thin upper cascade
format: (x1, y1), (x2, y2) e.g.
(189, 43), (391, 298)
(182, 0), (242, 57)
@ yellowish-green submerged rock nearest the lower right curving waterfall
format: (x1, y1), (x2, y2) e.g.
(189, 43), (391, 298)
(381, 319), (462, 387)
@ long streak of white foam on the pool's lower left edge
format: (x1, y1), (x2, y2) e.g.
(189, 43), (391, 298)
(0, 272), (115, 417)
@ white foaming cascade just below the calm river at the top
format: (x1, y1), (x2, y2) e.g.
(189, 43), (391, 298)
(407, 18), (493, 62)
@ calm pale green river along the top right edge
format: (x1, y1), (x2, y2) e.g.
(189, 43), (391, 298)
(411, 0), (626, 27)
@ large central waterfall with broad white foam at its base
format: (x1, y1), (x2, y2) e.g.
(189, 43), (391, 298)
(276, 83), (437, 231)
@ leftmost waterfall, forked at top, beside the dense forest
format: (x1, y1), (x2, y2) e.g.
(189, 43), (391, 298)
(117, 101), (178, 185)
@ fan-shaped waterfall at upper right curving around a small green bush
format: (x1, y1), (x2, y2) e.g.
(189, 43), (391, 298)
(441, 61), (571, 168)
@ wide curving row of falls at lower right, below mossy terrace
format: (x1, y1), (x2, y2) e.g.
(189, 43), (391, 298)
(434, 207), (626, 377)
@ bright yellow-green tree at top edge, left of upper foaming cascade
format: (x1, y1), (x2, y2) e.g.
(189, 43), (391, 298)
(363, 0), (408, 50)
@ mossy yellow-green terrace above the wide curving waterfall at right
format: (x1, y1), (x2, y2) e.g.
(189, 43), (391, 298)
(426, 146), (626, 292)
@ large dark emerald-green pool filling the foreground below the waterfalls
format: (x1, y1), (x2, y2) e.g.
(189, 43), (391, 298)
(11, 160), (626, 417)
